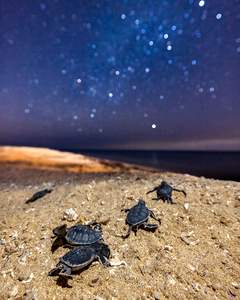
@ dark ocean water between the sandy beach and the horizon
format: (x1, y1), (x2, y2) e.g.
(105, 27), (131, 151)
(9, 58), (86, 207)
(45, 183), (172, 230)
(63, 149), (240, 181)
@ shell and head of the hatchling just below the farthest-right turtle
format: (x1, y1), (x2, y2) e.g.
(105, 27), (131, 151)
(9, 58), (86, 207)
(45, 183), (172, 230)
(127, 200), (149, 225)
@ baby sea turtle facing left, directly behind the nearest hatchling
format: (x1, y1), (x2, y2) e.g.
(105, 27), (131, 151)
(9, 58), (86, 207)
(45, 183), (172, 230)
(53, 224), (103, 246)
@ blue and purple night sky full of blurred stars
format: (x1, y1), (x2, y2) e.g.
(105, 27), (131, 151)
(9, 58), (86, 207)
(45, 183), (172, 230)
(0, 0), (240, 150)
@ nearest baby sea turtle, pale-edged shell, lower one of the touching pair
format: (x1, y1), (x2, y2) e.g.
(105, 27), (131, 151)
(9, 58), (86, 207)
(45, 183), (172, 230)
(48, 242), (110, 279)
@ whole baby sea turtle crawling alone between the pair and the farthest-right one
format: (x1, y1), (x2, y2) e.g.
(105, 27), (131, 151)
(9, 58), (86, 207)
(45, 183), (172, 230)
(122, 200), (160, 239)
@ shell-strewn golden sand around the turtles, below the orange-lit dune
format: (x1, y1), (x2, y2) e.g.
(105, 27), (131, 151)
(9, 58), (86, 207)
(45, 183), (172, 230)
(0, 158), (240, 300)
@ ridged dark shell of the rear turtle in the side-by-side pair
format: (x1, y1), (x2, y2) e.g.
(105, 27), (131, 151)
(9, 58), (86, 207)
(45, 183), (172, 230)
(65, 225), (102, 245)
